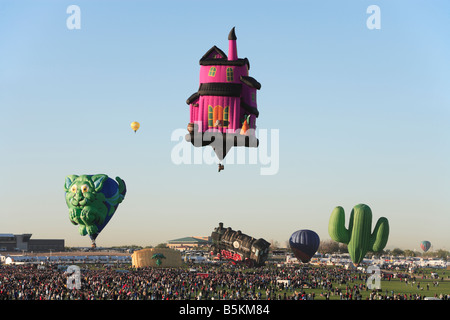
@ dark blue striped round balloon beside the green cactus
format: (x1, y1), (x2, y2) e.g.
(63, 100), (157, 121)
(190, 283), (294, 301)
(289, 229), (320, 263)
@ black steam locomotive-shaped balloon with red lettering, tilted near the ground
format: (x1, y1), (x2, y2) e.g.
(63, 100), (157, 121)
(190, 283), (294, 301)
(211, 223), (270, 267)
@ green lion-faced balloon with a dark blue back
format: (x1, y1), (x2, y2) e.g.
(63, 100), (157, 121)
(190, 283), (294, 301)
(64, 174), (126, 248)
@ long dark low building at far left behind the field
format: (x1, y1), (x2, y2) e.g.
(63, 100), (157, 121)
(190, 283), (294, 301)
(0, 233), (64, 252)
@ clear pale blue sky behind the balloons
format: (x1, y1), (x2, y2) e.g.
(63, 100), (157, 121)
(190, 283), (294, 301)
(0, 0), (450, 250)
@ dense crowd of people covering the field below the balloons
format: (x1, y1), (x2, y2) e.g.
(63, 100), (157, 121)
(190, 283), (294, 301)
(0, 265), (450, 300)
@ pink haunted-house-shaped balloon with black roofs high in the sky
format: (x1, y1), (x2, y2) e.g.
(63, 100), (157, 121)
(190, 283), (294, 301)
(186, 28), (261, 172)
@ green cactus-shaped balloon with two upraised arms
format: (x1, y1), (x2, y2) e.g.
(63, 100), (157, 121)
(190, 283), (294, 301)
(328, 204), (389, 266)
